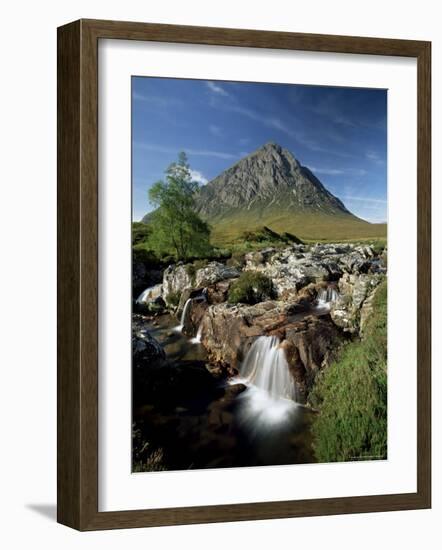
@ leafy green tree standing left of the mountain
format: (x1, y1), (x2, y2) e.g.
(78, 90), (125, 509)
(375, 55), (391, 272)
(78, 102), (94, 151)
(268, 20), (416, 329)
(149, 153), (211, 260)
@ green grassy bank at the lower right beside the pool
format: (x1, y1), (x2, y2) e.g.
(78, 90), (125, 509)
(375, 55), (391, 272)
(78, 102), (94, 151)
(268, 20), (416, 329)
(309, 282), (387, 462)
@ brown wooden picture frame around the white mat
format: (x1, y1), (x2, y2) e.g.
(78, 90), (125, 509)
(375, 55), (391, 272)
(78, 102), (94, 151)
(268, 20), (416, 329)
(58, 20), (431, 531)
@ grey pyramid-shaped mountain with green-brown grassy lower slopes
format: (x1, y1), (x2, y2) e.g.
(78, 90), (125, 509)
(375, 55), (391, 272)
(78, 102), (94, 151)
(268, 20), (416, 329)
(143, 142), (386, 245)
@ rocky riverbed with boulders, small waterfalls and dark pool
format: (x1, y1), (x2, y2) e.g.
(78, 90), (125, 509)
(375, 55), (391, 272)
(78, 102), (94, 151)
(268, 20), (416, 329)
(132, 243), (386, 471)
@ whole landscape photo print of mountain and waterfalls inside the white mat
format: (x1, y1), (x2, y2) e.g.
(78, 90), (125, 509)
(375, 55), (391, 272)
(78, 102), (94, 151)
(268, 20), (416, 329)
(131, 77), (387, 472)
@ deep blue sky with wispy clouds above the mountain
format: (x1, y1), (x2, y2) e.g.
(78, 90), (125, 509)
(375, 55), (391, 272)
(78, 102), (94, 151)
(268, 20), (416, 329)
(132, 77), (387, 222)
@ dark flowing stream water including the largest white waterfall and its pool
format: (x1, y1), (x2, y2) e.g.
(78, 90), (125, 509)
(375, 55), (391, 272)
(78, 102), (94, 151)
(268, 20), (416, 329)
(134, 314), (314, 470)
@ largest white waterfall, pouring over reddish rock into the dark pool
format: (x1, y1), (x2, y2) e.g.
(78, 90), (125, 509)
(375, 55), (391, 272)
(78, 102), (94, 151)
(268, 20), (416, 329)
(240, 336), (297, 401)
